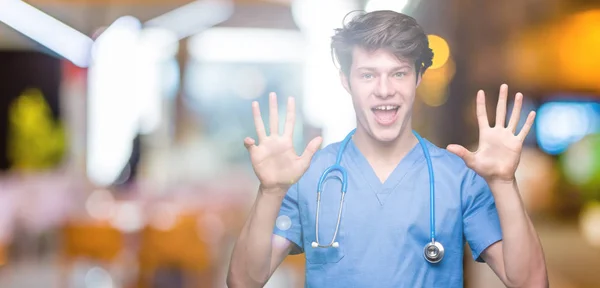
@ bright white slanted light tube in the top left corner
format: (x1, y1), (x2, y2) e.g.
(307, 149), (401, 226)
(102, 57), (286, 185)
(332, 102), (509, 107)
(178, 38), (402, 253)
(0, 0), (93, 68)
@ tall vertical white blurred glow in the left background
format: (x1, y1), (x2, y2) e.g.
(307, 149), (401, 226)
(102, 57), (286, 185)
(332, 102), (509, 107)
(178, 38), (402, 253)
(87, 16), (142, 186)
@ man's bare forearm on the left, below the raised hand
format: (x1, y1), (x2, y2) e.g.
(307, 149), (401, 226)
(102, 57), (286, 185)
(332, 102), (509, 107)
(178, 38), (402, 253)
(227, 188), (285, 287)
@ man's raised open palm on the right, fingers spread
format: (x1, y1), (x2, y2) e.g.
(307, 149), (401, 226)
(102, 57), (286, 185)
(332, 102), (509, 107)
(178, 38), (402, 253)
(447, 84), (535, 182)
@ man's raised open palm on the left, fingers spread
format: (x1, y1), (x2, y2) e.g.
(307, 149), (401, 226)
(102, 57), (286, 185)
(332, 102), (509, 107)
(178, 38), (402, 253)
(244, 93), (322, 193)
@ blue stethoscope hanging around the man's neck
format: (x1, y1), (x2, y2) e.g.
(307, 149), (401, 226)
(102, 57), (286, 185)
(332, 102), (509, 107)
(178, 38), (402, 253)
(311, 129), (444, 264)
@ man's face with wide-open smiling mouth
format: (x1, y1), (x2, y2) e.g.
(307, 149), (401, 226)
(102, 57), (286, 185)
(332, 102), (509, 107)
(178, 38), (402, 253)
(340, 47), (421, 142)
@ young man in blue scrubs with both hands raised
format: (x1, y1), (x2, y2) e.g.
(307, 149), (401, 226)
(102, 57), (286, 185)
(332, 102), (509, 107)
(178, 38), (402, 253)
(227, 11), (548, 287)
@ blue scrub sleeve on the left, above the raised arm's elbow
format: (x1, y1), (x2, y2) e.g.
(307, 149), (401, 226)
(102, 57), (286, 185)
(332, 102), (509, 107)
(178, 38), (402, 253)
(273, 183), (304, 255)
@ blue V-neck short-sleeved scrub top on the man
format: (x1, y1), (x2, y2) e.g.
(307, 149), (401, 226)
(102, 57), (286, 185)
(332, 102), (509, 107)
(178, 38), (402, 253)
(274, 139), (502, 288)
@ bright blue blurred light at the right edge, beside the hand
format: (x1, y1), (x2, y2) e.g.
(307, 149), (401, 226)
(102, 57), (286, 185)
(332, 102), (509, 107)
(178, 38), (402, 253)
(536, 102), (600, 154)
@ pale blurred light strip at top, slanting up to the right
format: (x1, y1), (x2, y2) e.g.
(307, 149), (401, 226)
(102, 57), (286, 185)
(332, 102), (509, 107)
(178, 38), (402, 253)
(146, 0), (234, 41)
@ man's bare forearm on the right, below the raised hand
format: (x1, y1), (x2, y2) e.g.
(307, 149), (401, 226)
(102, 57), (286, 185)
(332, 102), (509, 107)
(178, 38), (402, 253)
(488, 181), (547, 287)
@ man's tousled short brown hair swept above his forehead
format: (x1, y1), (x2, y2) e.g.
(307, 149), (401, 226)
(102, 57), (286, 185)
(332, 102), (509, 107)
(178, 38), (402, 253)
(331, 10), (433, 76)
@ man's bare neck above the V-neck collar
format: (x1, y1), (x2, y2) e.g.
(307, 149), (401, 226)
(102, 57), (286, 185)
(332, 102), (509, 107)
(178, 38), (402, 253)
(352, 123), (419, 165)
